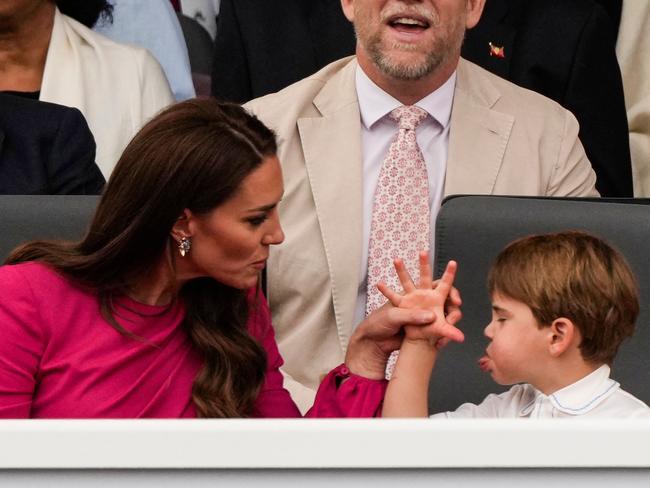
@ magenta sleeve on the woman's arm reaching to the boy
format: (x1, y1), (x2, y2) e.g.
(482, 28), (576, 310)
(248, 292), (387, 418)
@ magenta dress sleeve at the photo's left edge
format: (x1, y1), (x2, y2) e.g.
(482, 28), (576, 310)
(0, 266), (46, 419)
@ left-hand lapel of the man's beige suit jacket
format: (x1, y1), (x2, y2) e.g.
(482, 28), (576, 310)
(298, 62), (363, 350)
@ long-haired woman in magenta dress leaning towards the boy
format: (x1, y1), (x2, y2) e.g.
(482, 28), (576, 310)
(0, 99), (433, 418)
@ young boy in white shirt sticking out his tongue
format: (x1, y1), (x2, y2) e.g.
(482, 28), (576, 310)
(381, 232), (650, 418)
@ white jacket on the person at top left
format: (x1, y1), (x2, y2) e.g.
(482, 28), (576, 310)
(40, 9), (174, 180)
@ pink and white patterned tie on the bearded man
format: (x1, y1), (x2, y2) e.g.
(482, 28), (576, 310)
(366, 106), (430, 379)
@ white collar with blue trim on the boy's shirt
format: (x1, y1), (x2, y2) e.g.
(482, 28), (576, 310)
(519, 364), (620, 416)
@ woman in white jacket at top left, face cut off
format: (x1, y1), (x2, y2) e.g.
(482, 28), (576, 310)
(0, 0), (173, 179)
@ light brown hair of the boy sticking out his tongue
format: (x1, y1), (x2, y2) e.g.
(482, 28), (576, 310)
(488, 231), (639, 364)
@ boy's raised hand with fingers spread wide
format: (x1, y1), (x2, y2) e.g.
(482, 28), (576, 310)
(377, 252), (465, 348)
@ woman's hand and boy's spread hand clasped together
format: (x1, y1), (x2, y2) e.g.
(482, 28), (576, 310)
(345, 252), (464, 379)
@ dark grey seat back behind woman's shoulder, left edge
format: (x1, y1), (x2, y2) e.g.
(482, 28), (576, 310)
(0, 195), (99, 262)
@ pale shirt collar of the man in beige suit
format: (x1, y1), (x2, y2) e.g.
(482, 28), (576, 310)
(355, 65), (456, 129)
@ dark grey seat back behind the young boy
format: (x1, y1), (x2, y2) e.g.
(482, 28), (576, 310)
(429, 196), (650, 413)
